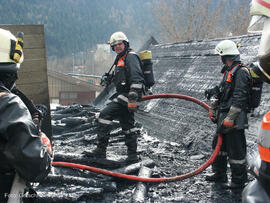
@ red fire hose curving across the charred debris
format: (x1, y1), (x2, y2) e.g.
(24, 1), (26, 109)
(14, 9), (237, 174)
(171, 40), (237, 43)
(52, 94), (222, 183)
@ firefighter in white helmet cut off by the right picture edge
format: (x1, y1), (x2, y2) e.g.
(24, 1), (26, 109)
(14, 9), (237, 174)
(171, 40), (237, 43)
(242, 0), (270, 203)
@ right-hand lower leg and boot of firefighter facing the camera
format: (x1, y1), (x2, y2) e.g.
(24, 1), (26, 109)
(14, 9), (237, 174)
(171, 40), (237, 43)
(125, 133), (139, 164)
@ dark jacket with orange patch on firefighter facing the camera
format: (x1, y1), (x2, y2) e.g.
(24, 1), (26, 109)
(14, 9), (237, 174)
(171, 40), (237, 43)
(113, 49), (144, 105)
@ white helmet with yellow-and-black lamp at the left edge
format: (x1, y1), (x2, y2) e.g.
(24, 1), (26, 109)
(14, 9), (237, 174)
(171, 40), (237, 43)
(0, 28), (23, 71)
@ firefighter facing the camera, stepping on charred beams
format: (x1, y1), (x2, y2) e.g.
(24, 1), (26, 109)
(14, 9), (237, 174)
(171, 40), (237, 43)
(89, 32), (144, 162)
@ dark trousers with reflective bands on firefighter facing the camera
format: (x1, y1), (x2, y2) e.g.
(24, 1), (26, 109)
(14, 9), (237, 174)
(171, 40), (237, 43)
(97, 102), (138, 153)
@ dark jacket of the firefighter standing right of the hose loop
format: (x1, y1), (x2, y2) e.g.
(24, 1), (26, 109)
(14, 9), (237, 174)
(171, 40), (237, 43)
(218, 62), (251, 129)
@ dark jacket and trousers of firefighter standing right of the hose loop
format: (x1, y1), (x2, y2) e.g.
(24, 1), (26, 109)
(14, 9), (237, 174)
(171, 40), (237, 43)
(212, 62), (251, 184)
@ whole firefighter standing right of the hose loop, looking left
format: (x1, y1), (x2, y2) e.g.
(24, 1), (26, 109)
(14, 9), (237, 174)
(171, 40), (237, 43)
(206, 40), (251, 189)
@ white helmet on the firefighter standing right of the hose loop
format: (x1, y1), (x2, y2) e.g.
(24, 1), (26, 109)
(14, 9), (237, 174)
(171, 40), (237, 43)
(215, 40), (240, 56)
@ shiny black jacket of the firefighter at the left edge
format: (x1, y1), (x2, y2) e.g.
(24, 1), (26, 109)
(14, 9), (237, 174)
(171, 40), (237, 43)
(0, 82), (51, 185)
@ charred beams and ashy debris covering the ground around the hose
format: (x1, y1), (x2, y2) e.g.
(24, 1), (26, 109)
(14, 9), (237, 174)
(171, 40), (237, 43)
(32, 101), (259, 203)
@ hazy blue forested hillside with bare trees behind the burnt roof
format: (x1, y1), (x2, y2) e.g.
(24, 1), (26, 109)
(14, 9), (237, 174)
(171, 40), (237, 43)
(0, 0), (250, 75)
